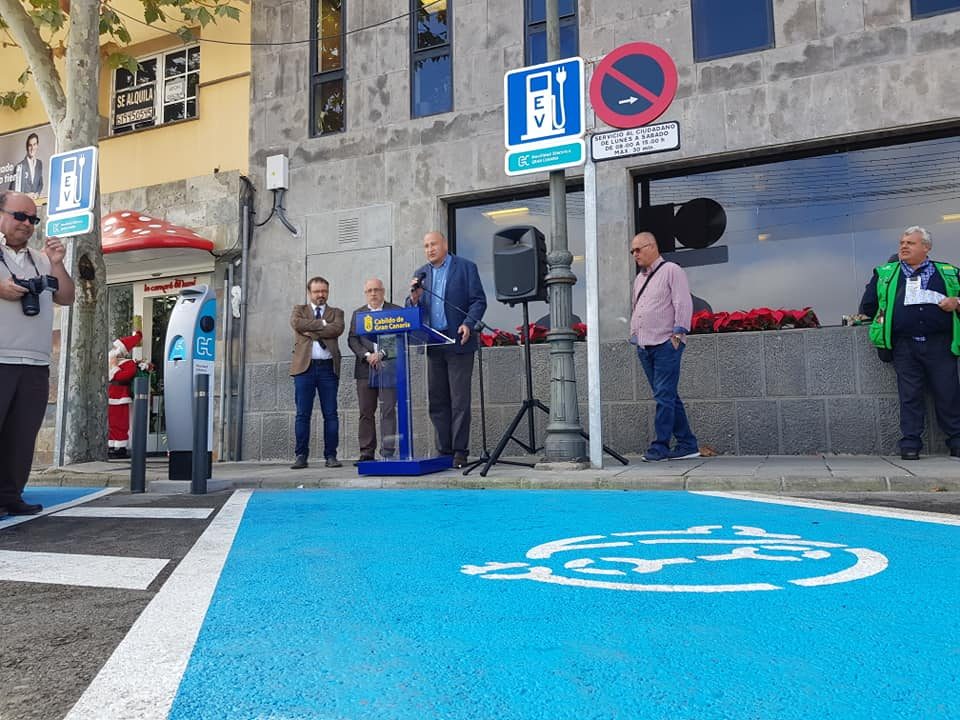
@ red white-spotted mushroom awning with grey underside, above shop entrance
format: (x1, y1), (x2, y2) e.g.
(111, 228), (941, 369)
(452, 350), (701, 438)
(100, 210), (215, 282)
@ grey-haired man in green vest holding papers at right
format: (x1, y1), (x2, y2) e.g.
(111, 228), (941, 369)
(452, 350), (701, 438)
(860, 226), (960, 460)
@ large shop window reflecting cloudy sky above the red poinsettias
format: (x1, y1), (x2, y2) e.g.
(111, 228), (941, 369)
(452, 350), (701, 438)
(637, 137), (960, 325)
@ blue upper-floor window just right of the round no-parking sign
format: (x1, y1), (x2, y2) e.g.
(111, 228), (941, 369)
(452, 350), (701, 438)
(690, 0), (774, 62)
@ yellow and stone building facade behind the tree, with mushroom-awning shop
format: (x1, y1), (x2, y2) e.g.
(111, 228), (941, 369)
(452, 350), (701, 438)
(0, 2), (250, 465)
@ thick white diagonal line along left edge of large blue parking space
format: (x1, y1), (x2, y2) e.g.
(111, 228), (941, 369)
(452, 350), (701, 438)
(64, 490), (252, 720)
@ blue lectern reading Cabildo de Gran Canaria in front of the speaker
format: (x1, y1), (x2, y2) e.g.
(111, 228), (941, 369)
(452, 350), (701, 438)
(355, 307), (453, 475)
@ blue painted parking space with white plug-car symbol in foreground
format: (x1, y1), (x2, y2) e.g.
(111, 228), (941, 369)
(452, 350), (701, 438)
(169, 490), (960, 720)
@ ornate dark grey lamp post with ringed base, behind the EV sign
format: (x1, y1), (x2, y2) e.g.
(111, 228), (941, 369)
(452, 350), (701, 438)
(544, 0), (596, 462)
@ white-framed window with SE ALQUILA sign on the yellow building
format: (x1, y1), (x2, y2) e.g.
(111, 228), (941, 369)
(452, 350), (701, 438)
(110, 46), (200, 135)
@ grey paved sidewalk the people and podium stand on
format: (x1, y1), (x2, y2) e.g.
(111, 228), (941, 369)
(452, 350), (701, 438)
(30, 455), (960, 493)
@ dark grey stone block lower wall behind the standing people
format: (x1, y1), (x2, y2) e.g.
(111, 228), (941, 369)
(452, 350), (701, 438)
(238, 327), (946, 460)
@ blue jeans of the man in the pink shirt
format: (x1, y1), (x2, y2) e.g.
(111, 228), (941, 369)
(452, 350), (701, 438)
(637, 340), (697, 456)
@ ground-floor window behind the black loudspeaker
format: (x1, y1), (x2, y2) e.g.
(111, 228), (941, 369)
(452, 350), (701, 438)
(450, 188), (587, 332)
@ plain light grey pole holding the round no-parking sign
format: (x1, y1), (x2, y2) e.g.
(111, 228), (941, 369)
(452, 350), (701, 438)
(583, 149), (603, 469)
